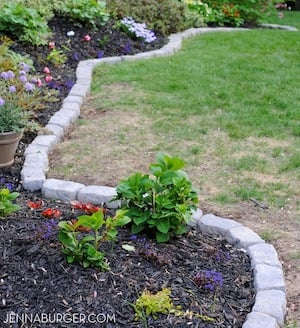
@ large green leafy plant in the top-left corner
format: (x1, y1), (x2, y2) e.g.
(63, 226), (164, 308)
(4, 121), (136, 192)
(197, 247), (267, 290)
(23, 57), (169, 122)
(0, 1), (51, 45)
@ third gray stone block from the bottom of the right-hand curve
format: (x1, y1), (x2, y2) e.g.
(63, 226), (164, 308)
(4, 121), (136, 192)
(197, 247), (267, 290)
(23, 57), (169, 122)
(254, 264), (285, 292)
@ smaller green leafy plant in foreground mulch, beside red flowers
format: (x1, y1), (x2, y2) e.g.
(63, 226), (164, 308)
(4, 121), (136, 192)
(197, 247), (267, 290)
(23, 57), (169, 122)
(58, 209), (130, 270)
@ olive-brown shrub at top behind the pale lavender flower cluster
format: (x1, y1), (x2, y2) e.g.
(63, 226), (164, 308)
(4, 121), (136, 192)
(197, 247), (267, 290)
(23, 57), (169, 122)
(107, 0), (187, 36)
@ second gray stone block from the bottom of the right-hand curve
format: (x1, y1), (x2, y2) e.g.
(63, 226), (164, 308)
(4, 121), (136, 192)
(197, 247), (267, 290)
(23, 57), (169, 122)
(252, 290), (286, 327)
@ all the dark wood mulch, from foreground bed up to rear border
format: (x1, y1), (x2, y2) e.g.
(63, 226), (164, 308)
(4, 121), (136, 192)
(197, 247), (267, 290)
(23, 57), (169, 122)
(0, 19), (254, 328)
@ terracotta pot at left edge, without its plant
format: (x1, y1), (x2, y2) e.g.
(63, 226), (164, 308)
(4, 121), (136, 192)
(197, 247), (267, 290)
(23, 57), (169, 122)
(0, 132), (23, 168)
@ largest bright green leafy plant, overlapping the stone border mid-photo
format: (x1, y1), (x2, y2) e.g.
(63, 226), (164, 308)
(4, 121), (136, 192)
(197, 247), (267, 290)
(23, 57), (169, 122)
(115, 153), (198, 242)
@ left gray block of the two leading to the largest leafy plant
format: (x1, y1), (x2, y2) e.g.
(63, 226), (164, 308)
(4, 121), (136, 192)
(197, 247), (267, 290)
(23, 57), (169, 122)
(42, 179), (85, 201)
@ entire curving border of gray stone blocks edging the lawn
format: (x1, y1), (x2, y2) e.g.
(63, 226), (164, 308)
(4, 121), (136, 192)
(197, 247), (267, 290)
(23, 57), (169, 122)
(21, 24), (297, 328)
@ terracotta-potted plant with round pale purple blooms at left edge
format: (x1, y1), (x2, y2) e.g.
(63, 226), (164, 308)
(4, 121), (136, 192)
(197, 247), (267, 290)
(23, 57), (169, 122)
(0, 63), (39, 168)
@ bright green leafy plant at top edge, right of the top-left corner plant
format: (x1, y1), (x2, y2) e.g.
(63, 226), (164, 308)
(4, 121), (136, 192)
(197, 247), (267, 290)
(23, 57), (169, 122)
(56, 0), (109, 28)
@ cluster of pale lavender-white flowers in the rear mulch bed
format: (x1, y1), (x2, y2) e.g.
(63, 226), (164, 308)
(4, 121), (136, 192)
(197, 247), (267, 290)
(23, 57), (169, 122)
(121, 17), (156, 43)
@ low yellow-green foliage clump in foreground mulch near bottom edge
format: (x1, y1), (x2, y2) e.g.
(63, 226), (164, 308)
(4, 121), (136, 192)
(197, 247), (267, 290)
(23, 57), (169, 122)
(135, 288), (177, 320)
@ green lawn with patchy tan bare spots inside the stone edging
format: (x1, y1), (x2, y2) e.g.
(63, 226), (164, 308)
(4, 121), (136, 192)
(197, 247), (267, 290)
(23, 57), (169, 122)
(49, 16), (300, 218)
